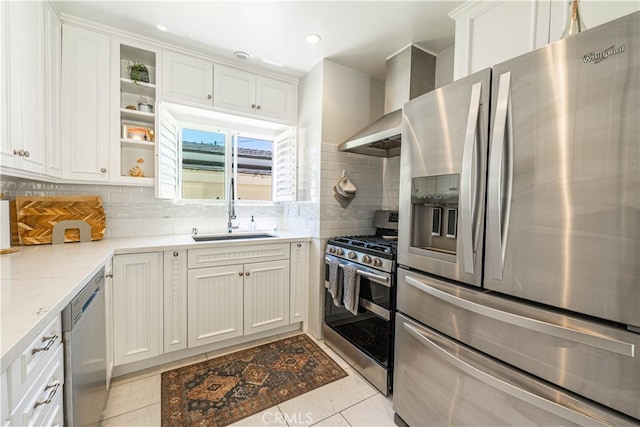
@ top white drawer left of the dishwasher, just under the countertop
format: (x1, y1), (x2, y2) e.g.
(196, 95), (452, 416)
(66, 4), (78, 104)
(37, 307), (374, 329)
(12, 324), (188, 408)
(8, 316), (62, 405)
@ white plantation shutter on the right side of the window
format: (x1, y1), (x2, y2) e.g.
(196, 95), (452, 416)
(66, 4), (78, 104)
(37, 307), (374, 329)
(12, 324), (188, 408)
(273, 128), (297, 201)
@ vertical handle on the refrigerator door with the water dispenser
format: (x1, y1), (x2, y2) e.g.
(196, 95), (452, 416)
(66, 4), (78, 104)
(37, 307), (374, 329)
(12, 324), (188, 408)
(460, 82), (482, 274)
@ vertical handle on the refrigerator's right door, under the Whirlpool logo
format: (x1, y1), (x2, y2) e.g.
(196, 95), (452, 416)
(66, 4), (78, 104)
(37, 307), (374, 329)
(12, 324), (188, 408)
(487, 72), (513, 280)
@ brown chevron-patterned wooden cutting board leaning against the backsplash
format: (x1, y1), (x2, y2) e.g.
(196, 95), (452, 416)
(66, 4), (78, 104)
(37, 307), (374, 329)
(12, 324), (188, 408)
(16, 196), (107, 245)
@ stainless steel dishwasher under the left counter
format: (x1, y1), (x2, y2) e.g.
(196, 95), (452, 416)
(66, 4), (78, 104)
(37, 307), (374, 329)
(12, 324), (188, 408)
(62, 267), (107, 426)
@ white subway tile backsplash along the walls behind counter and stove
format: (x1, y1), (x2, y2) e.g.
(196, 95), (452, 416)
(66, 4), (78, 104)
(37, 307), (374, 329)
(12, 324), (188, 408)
(0, 150), (400, 238)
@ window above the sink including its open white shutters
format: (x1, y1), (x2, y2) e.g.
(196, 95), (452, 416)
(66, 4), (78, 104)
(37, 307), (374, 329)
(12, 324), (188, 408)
(157, 104), (296, 201)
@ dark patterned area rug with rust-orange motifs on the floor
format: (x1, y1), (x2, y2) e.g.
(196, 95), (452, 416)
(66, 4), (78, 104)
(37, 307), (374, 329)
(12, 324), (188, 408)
(161, 334), (347, 427)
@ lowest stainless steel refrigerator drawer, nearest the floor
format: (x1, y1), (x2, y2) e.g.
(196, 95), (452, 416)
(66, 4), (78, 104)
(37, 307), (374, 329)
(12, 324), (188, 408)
(393, 314), (637, 426)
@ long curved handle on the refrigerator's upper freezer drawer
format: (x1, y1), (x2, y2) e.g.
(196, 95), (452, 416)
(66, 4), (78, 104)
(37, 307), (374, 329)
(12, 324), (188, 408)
(405, 276), (635, 357)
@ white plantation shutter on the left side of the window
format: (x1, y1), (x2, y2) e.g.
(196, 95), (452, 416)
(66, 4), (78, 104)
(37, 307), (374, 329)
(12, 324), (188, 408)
(156, 102), (180, 200)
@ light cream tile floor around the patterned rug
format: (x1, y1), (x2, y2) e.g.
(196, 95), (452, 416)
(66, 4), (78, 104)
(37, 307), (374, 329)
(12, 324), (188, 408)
(100, 332), (395, 427)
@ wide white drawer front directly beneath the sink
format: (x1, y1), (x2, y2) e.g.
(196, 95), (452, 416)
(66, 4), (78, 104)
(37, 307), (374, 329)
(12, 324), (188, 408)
(187, 243), (289, 268)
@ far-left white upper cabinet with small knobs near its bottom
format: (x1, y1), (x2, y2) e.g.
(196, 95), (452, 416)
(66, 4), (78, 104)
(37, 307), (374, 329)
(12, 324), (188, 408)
(0, 2), (46, 174)
